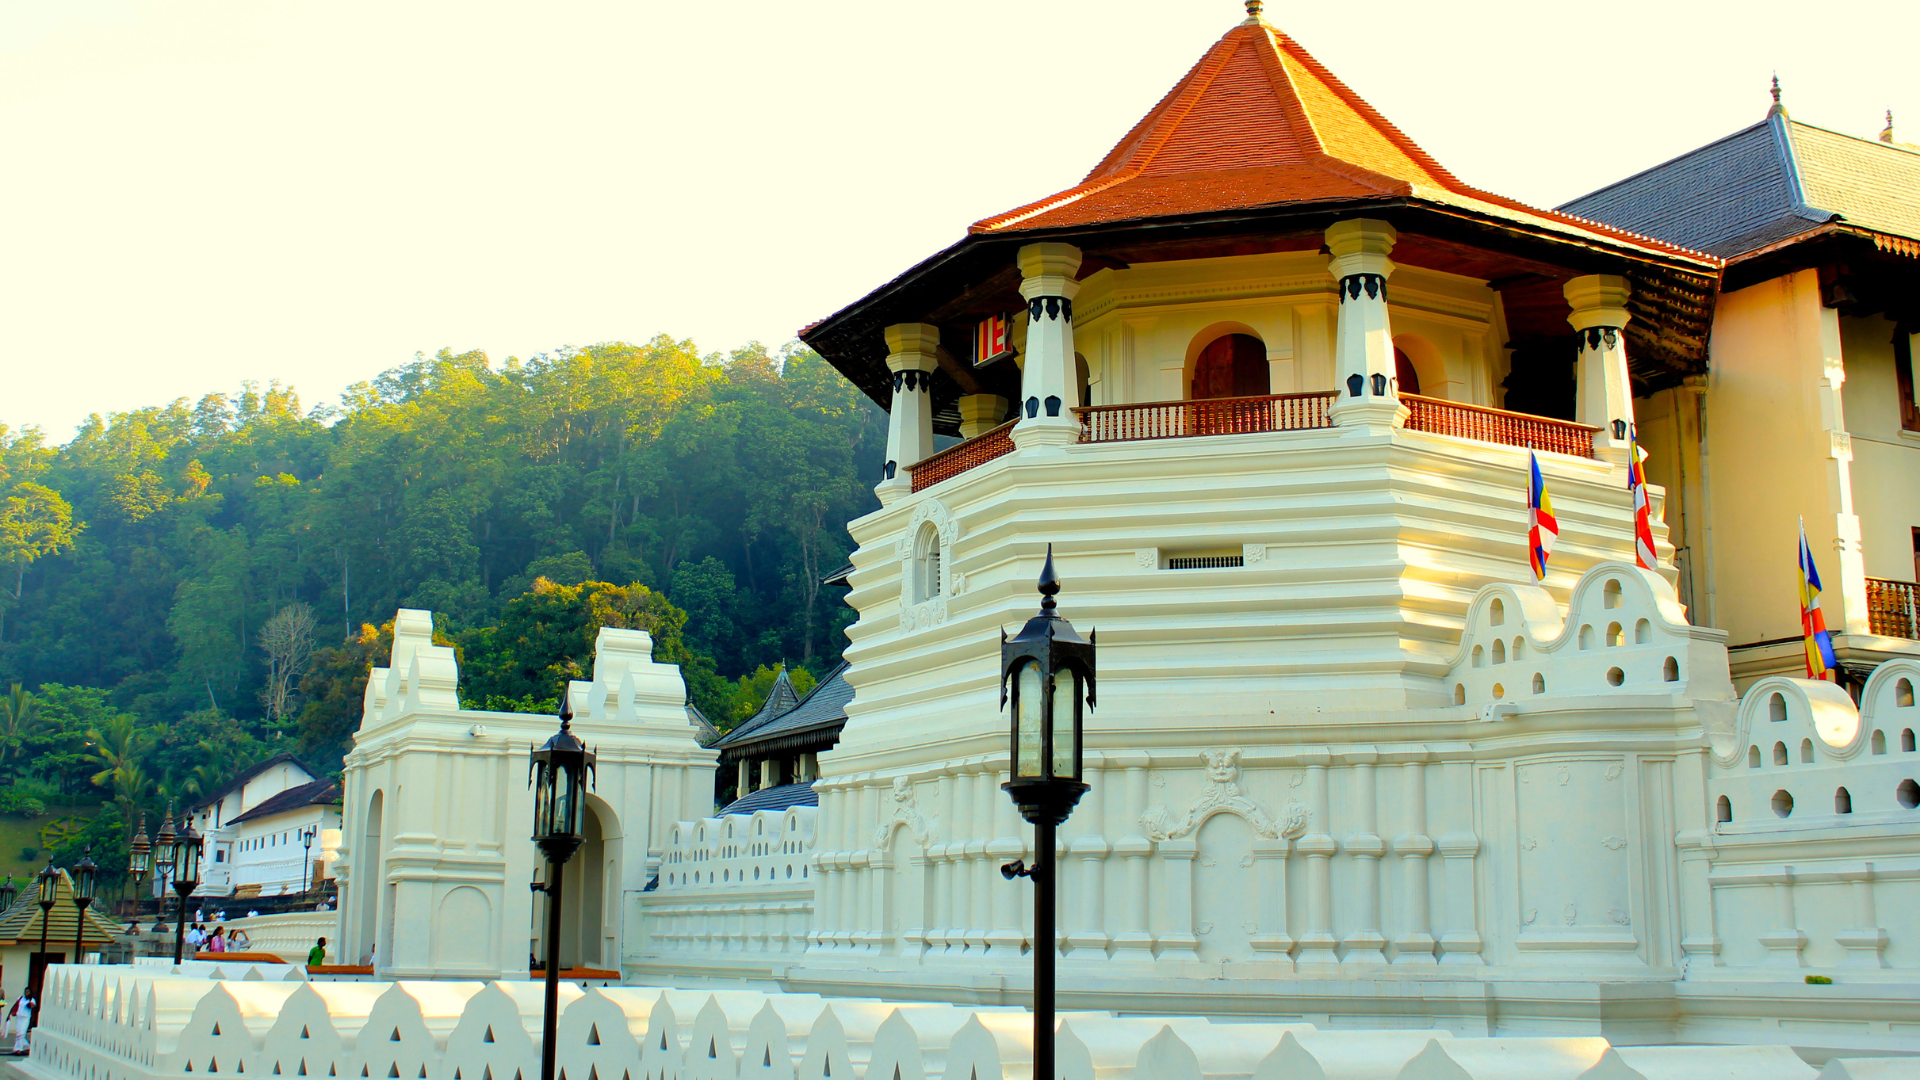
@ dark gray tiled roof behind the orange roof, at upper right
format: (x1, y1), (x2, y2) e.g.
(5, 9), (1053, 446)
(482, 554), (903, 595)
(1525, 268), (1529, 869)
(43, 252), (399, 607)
(1559, 113), (1920, 258)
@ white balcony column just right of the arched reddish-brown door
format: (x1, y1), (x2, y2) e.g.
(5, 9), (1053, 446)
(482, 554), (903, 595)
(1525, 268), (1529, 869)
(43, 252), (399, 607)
(1327, 217), (1407, 432)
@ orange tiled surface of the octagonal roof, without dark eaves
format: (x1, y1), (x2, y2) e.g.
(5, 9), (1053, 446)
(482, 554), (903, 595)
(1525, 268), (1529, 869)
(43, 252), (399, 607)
(972, 19), (1715, 261)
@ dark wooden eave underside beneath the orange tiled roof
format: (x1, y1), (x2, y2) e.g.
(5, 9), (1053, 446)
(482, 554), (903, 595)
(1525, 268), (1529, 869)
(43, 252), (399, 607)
(801, 196), (1720, 434)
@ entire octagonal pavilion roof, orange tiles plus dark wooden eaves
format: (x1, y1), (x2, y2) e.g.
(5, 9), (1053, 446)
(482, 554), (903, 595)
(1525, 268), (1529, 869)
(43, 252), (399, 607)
(801, 15), (1722, 434)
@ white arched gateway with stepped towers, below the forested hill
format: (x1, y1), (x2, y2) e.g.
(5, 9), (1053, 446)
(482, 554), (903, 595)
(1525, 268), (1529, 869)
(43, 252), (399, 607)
(328, 609), (716, 978)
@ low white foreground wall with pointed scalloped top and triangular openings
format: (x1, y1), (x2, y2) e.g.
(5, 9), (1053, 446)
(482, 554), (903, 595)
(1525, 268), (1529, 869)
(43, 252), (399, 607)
(23, 967), (1920, 1080)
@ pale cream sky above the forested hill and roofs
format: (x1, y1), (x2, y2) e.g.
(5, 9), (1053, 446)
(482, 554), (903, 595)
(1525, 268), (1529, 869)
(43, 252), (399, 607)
(0, 0), (1920, 442)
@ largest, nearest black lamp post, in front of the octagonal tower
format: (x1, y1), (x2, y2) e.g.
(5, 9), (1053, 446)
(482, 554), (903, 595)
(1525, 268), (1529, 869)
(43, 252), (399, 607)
(1000, 544), (1094, 1080)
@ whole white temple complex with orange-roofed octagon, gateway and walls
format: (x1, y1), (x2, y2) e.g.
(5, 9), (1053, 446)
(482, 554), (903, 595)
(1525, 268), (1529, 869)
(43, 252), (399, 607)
(35, 4), (1920, 1080)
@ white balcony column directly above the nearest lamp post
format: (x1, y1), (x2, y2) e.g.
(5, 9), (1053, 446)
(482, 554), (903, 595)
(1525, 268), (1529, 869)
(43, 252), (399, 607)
(1014, 244), (1081, 450)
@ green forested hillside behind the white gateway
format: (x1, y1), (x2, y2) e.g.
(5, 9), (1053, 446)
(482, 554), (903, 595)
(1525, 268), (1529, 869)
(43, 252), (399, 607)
(0, 336), (885, 883)
